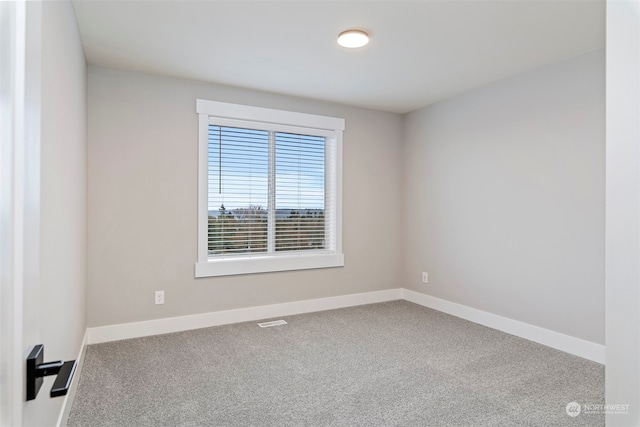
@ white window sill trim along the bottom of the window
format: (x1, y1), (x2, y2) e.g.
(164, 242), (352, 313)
(196, 254), (344, 277)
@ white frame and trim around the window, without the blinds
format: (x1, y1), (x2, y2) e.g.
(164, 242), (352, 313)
(195, 99), (345, 277)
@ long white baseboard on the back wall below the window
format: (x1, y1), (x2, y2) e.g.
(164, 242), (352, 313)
(88, 288), (402, 344)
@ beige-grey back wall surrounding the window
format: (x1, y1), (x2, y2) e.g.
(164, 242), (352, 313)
(88, 66), (401, 327)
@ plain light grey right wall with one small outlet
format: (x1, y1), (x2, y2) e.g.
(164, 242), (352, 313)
(402, 50), (605, 344)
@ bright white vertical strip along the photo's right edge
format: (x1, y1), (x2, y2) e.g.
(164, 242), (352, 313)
(606, 1), (640, 426)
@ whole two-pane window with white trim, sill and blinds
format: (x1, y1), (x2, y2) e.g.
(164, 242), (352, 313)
(196, 100), (344, 277)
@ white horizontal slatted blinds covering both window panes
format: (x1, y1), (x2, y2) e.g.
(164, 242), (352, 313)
(208, 125), (333, 257)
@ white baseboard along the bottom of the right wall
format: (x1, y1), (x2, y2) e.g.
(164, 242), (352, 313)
(402, 288), (605, 364)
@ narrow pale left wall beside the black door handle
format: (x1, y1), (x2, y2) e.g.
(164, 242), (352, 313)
(24, 1), (87, 426)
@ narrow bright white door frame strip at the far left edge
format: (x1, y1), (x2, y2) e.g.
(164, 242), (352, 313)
(0, 2), (26, 426)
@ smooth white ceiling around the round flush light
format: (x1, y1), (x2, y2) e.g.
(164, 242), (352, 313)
(73, 0), (605, 113)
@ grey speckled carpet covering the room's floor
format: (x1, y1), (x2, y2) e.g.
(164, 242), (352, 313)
(68, 301), (604, 427)
